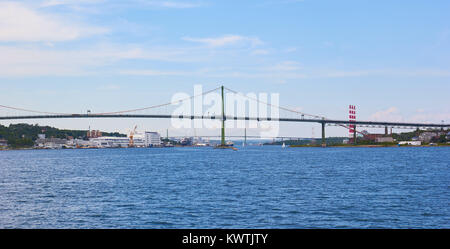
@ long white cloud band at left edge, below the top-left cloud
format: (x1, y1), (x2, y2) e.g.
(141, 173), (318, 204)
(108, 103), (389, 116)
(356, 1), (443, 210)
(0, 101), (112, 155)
(0, 45), (193, 77)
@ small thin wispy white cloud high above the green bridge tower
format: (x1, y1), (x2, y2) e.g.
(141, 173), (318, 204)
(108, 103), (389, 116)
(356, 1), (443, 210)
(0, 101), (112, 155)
(182, 35), (263, 48)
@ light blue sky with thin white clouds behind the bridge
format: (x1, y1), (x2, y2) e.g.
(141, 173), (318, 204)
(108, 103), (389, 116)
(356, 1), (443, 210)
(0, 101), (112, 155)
(0, 0), (450, 137)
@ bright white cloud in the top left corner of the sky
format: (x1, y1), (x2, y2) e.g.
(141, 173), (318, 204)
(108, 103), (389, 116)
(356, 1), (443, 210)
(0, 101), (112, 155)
(0, 2), (108, 42)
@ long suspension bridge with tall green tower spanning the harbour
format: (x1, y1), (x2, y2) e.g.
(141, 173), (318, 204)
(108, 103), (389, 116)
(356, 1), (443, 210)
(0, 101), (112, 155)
(0, 86), (450, 146)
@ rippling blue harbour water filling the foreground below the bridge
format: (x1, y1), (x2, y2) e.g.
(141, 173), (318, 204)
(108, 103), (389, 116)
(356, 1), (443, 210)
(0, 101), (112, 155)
(0, 146), (450, 228)
